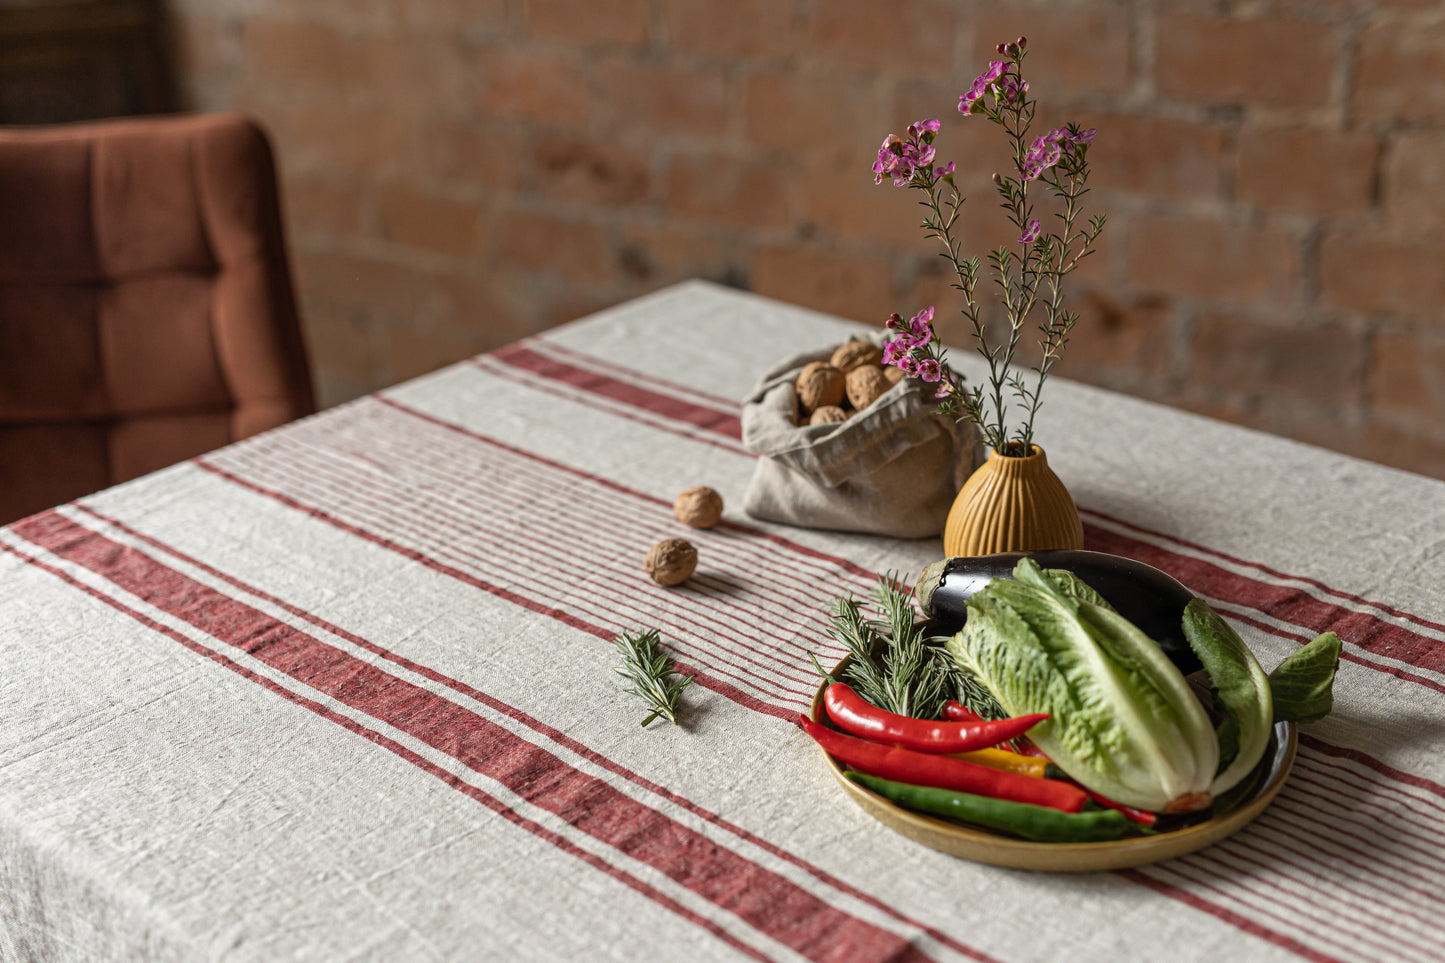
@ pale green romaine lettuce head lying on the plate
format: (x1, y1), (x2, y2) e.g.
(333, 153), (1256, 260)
(948, 558), (1220, 813)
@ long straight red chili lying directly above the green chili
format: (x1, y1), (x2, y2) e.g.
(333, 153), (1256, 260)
(798, 711), (1088, 813)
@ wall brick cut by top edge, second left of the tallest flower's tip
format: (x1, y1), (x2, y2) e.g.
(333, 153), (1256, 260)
(663, 0), (803, 61)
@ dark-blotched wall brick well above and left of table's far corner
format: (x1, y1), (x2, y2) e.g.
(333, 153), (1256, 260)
(523, 136), (652, 207)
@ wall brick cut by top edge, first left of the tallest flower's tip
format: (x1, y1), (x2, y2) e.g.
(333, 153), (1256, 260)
(803, 0), (958, 74)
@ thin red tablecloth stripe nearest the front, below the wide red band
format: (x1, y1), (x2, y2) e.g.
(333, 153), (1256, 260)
(0, 540), (770, 963)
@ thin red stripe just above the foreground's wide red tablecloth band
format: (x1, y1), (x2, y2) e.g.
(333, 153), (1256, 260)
(72, 502), (991, 960)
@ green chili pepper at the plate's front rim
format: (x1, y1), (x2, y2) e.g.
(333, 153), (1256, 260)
(847, 771), (1130, 843)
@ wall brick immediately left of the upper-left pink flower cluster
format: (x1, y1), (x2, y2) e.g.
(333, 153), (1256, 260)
(743, 74), (890, 161)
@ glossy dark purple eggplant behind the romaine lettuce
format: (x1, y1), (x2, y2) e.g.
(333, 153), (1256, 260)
(913, 548), (1204, 675)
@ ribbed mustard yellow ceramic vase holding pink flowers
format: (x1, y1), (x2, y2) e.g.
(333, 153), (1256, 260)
(944, 445), (1084, 555)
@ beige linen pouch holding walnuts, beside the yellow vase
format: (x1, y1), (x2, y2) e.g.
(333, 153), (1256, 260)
(743, 344), (987, 538)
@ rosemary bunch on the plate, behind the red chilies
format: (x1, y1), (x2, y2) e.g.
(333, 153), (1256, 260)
(814, 573), (957, 719)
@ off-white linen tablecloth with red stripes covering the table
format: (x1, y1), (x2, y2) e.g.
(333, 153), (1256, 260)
(0, 283), (1445, 962)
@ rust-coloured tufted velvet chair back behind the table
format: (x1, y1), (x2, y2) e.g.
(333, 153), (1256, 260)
(0, 114), (315, 523)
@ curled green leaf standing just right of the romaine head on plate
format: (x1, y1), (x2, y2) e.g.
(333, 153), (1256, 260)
(1183, 599), (1274, 795)
